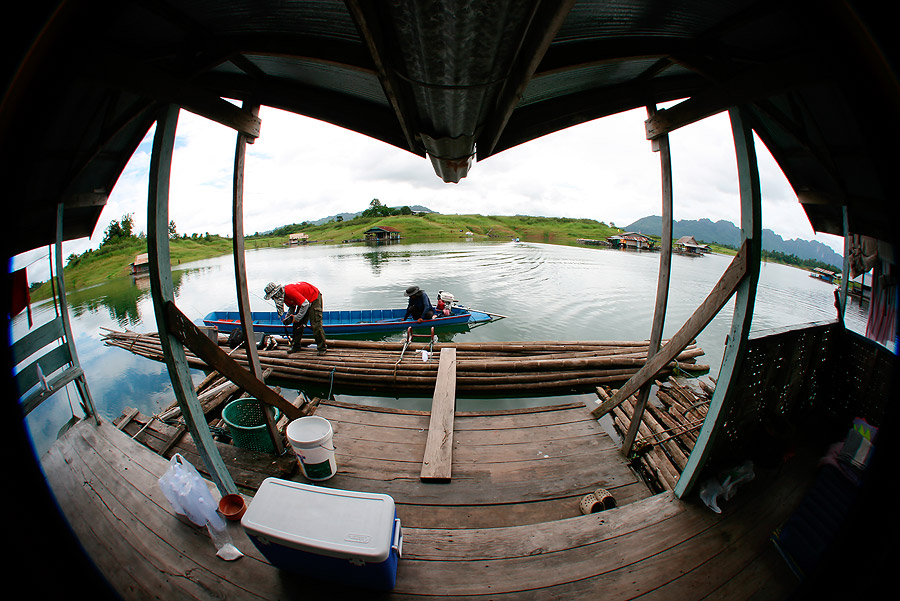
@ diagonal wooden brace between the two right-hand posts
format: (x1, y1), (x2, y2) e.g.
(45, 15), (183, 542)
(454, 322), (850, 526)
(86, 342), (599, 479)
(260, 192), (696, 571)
(591, 241), (750, 418)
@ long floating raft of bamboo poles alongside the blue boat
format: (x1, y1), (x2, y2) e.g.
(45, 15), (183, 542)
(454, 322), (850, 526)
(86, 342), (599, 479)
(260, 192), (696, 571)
(103, 328), (709, 396)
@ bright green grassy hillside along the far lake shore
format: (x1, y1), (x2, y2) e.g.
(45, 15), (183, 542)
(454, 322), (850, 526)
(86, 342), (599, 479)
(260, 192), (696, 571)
(31, 213), (621, 300)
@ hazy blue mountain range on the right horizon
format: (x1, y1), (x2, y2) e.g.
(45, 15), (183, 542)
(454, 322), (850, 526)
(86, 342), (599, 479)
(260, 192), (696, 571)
(625, 215), (844, 271)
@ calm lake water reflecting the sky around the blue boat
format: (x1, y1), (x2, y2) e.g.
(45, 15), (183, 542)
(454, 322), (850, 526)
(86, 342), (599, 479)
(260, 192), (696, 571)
(13, 241), (865, 454)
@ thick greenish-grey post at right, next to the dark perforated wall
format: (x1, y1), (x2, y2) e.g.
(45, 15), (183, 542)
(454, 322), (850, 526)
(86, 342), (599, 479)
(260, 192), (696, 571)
(674, 108), (762, 498)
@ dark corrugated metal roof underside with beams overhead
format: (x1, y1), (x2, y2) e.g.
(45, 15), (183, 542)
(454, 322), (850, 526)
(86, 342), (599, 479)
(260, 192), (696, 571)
(0, 0), (900, 253)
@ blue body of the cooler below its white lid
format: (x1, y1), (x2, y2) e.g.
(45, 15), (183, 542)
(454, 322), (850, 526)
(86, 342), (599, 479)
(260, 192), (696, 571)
(247, 510), (400, 590)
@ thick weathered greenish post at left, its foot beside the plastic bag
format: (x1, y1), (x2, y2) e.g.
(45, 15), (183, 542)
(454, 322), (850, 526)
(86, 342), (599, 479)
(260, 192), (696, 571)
(147, 104), (238, 495)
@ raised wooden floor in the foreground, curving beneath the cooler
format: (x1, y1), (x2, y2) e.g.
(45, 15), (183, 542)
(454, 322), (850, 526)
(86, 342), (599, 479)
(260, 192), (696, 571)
(42, 418), (800, 601)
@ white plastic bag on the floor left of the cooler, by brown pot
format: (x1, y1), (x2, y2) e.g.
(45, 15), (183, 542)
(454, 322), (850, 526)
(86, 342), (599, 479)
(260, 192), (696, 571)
(159, 453), (243, 561)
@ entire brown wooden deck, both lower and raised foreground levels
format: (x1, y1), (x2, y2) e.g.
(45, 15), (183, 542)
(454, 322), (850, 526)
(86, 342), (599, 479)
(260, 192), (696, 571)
(42, 396), (811, 600)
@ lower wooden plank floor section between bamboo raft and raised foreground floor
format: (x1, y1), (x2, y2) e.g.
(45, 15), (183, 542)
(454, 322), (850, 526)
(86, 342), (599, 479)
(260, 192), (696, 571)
(316, 401), (650, 528)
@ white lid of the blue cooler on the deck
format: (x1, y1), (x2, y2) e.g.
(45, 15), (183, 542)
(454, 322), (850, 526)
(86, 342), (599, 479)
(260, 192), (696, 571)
(241, 478), (395, 563)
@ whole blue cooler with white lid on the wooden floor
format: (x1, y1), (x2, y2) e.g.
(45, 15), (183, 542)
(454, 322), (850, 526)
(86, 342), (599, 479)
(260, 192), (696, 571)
(241, 478), (403, 590)
